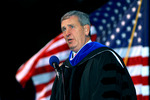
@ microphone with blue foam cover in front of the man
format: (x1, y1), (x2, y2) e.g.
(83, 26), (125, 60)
(49, 56), (60, 78)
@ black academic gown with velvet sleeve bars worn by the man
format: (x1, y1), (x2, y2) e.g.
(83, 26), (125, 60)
(50, 47), (137, 100)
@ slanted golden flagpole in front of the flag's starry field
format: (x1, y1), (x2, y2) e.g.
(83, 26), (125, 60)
(124, 0), (142, 65)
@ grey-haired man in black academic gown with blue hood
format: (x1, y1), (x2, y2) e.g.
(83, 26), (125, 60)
(51, 11), (136, 100)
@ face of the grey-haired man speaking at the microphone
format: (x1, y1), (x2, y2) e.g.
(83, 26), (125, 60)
(61, 16), (88, 52)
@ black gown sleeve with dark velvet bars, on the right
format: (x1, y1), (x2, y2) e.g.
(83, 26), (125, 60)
(89, 52), (136, 100)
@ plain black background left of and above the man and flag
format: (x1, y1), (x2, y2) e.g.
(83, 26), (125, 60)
(0, 0), (108, 100)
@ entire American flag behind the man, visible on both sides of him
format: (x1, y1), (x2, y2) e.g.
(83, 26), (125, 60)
(16, 0), (149, 100)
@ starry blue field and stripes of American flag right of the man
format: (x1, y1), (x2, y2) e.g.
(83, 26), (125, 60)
(90, 0), (149, 100)
